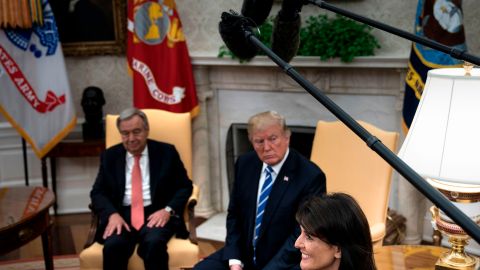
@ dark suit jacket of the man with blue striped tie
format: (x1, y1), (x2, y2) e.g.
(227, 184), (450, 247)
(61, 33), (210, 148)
(223, 149), (326, 270)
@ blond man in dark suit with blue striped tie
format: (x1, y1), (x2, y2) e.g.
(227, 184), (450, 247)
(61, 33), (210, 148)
(194, 111), (326, 270)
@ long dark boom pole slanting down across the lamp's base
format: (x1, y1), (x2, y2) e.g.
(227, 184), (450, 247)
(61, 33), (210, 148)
(241, 21), (480, 243)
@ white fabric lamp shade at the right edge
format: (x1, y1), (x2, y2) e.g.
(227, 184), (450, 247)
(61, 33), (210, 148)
(398, 68), (480, 190)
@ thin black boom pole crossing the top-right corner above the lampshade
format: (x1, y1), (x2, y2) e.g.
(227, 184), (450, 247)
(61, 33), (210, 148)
(307, 0), (480, 66)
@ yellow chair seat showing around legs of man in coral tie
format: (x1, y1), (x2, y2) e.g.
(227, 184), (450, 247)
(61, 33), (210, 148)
(79, 238), (198, 270)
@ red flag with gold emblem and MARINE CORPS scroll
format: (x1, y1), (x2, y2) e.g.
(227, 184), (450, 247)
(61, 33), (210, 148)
(127, 0), (198, 117)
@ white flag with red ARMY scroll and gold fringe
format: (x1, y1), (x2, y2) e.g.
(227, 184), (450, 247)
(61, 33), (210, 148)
(0, 0), (76, 158)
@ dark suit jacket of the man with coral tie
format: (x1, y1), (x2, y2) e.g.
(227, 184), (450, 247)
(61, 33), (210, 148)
(90, 140), (193, 240)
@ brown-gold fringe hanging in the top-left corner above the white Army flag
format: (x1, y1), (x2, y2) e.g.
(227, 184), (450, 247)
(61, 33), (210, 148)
(0, 0), (43, 29)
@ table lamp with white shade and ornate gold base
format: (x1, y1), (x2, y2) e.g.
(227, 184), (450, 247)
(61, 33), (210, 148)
(398, 65), (480, 269)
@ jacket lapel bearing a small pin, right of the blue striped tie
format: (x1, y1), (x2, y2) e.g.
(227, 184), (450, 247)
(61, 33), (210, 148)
(259, 151), (295, 238)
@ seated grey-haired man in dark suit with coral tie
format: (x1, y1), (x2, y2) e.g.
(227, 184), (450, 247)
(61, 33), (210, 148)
(90, 108), (192, 270)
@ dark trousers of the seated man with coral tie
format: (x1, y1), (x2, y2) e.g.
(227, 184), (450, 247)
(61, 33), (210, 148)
(103, 207), (175, 270)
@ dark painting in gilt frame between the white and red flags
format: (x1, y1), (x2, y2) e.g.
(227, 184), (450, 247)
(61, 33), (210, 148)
(49, 0), (126, 56)
